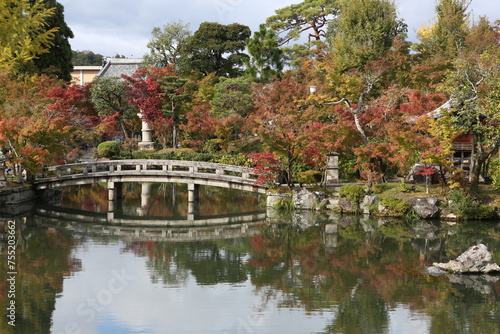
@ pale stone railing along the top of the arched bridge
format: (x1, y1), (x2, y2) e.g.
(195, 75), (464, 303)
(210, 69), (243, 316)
(35, 160), (258, 183)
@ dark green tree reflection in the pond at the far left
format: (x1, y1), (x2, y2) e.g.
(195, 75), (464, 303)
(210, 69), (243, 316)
(0, 218), (81, 333)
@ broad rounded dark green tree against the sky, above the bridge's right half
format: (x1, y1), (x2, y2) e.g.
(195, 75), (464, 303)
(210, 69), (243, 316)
(179, 22), (251, 77)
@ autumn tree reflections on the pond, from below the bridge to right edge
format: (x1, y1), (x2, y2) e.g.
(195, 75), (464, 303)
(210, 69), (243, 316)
(114, 215), (500, 334)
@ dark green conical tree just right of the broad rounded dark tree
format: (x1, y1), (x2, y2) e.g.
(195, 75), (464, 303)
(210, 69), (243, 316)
(244, 24), (283, 82)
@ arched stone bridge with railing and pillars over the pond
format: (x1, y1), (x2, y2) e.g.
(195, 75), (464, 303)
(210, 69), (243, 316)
(34, 160), (266, 202)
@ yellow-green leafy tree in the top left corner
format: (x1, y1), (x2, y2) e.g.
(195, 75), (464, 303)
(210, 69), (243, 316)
(0, 0), (57, 70)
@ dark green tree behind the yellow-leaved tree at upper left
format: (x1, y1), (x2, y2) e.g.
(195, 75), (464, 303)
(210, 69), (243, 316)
(29, 0), (74, 82)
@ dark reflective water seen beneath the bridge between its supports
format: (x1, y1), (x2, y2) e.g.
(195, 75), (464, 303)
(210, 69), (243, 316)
(58, 183), (263, 218)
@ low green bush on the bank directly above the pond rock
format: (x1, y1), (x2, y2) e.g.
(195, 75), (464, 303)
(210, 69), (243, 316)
(448, 188), (494, 219)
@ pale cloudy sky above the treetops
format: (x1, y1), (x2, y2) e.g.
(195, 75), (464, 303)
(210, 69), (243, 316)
(59, 0), (500, 57)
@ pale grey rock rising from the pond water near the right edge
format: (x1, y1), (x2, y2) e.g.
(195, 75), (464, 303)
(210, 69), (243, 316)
(433, 244), (500, 274)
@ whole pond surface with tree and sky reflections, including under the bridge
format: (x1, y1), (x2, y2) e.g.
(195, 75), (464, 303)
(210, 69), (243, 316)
(0, 184), (500, 334)
